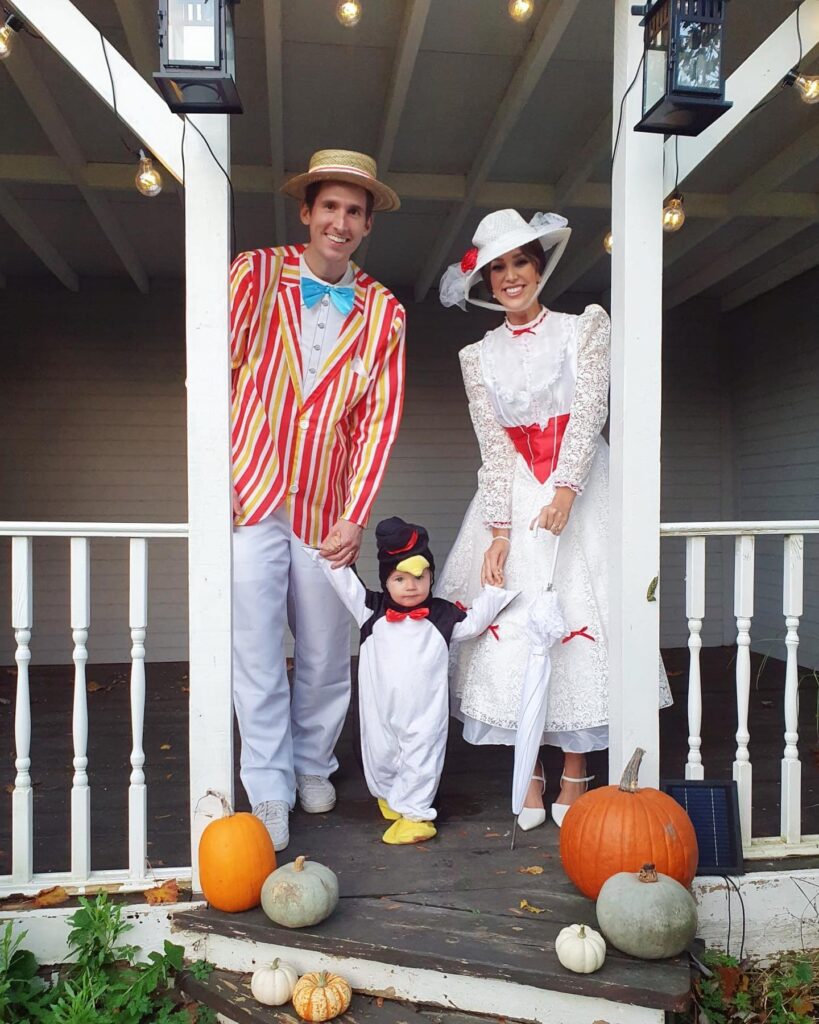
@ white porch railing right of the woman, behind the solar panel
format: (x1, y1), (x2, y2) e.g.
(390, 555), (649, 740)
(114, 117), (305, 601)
(660, 519), (819, 858)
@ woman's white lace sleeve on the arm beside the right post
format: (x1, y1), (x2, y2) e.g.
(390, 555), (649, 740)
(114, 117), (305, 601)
(555, 306), (610, 495)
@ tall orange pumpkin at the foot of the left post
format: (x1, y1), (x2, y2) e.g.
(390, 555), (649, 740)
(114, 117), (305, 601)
(199, 794), (275, 913)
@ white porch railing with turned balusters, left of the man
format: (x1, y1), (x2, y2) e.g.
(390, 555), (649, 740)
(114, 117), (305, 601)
(0, 522), (190, 895)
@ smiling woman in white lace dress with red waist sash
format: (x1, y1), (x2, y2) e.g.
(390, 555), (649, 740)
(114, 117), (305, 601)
(436, 210), (667, 828)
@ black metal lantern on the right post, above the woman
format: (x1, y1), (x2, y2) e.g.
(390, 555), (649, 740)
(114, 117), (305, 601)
(632, 0), (732, 135)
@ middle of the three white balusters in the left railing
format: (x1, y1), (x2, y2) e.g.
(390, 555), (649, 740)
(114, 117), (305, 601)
(71, 537), (91, 881)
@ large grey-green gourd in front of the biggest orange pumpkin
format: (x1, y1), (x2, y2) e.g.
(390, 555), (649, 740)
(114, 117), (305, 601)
(597, 864), (697, 959)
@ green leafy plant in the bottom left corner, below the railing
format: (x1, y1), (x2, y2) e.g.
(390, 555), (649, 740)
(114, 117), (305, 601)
(0, 893), (215, 1024)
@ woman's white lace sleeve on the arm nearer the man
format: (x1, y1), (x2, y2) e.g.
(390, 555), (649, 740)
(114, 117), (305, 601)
(461, 344), (516, 526)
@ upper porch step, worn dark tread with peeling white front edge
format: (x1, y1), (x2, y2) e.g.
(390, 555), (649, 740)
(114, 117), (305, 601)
(173, 880), (691, 1020)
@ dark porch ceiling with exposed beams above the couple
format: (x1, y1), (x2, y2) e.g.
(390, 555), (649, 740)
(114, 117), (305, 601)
(0, 0), (819, 308)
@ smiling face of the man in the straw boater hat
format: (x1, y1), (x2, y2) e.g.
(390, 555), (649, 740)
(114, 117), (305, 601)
(301, 181), (373, 281)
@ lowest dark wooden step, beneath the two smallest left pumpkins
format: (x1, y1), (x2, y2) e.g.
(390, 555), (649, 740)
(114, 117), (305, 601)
(176, 971), (498, 1024)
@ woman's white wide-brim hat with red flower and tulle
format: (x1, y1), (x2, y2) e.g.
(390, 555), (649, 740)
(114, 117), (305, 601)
(438, 210), (571, 312)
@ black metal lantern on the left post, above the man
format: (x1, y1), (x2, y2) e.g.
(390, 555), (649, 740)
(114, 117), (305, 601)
(154, 0), (242, 114)
